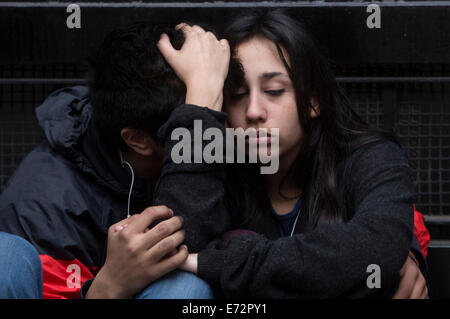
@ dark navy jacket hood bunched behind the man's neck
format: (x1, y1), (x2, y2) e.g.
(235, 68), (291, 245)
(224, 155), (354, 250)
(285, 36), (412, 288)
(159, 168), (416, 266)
(36, 86), (151, 200)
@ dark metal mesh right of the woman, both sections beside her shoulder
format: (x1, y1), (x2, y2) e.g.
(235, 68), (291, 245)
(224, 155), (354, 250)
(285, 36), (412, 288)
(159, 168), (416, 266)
(344, 83), (450, 215)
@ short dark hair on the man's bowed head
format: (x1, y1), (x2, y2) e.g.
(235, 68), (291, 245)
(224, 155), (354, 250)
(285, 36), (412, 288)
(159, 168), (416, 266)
(87, 22), (186, 147)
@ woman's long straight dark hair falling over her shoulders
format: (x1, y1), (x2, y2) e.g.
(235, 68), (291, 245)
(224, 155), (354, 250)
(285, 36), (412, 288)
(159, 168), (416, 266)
(223, 10), (396, 229)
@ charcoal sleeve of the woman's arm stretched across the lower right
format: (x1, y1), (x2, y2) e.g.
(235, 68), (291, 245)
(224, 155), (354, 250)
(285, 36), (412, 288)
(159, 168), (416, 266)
(198, 143), (413, 298)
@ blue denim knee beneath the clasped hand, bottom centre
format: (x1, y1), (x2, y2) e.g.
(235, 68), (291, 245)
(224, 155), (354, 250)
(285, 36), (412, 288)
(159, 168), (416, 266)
(135, 270), (214, 299)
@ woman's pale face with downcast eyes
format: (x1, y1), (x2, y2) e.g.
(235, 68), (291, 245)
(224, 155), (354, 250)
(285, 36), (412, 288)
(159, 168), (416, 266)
(224, 37), (303, 165)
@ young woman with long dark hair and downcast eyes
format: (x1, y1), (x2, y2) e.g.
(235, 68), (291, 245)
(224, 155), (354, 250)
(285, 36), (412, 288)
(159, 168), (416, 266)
(158, 11), (427, 298)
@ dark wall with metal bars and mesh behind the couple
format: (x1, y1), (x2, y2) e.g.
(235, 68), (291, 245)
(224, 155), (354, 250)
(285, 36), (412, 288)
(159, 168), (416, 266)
(0, 1), (450, 297)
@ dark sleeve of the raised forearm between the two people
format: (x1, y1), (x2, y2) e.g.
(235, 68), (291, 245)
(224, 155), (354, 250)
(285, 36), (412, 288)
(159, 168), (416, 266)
(153, 104), (230, 253)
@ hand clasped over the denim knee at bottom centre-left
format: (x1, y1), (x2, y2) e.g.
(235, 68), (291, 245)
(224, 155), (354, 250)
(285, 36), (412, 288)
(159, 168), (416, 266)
(86, 206), (188, 298)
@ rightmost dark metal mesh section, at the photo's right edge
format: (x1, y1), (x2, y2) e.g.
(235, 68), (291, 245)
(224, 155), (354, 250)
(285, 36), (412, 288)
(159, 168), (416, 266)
(397, 84), (450, 215)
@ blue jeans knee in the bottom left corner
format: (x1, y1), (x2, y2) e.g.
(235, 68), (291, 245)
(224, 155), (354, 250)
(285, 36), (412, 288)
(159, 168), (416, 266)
(0, 232), (43, 299)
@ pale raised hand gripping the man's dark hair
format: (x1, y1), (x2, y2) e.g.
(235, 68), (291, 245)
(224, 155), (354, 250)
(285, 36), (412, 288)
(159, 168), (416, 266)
(157, 23), (230, 111)
